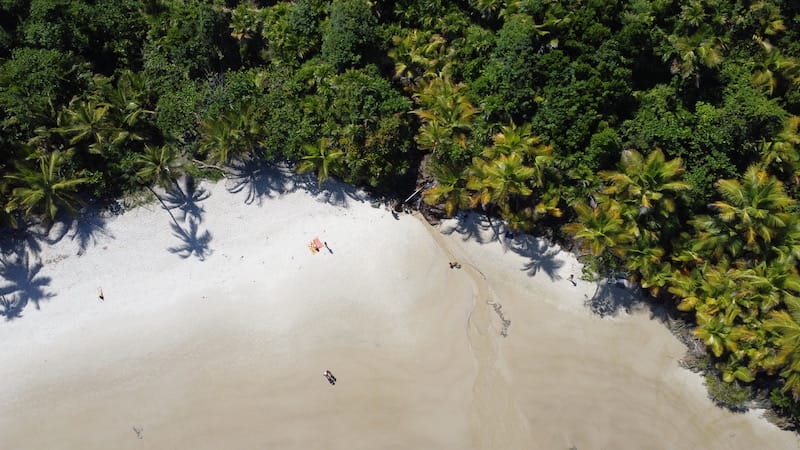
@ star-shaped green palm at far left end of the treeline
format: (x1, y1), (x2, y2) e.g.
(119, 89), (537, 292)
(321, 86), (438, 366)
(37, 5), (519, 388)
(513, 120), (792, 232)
(5, 151), (89, 223)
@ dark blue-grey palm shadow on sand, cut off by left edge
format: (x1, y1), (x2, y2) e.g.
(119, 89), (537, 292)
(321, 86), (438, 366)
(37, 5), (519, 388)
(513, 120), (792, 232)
(0, 251), (55, 321)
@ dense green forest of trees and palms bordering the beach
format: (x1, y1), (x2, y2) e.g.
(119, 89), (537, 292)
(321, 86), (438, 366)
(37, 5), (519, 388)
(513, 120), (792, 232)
(0, 0), (800, 428)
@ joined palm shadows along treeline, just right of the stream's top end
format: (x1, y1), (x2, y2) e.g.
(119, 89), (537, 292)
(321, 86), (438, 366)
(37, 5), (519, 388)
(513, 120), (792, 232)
(440, 213), (564, 280)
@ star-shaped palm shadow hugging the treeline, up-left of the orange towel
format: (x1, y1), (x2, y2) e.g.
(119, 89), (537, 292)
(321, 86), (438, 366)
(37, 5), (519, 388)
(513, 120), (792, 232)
(227, 157), (298, 206)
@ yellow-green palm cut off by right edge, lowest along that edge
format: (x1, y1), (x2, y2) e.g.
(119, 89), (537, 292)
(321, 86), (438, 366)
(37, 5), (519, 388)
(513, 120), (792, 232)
(764, 298), (800, 400)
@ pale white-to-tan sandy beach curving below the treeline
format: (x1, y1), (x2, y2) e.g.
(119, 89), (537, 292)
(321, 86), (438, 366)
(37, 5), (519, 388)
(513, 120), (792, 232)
(0, 170), (800, 450)
